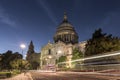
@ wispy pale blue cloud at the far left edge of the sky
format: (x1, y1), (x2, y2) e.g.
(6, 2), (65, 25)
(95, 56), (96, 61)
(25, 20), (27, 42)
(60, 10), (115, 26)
(0, 7), (16, 27)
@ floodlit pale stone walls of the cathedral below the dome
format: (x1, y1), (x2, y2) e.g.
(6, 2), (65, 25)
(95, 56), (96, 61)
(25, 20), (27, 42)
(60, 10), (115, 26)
(40, 41), (86, 67)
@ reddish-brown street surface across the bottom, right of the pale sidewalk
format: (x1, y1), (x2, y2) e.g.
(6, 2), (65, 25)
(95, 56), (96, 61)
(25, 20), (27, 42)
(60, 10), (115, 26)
(31, 72), (120, 80)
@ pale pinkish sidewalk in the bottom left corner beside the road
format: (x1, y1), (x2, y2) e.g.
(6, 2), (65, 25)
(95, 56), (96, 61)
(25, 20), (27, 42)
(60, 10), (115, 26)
(1, 73), (33, 80)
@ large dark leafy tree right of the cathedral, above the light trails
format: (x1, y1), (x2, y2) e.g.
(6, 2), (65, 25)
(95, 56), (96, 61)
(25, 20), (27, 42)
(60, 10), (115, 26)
(85, 29), (120, 56)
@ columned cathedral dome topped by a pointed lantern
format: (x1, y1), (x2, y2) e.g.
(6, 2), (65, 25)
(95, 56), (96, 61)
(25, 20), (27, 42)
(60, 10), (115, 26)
(54, 13), (78, 44)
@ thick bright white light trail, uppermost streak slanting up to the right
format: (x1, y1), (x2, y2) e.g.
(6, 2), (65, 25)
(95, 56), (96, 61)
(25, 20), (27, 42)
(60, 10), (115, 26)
(58, 51), (120, 64)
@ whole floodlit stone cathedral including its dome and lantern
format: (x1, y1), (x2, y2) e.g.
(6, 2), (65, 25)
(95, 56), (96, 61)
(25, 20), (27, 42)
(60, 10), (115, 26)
(40, 13), (86, 69)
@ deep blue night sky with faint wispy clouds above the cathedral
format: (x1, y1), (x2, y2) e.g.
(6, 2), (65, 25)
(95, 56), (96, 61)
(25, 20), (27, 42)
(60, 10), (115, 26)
(0, 0), (120, 53)
